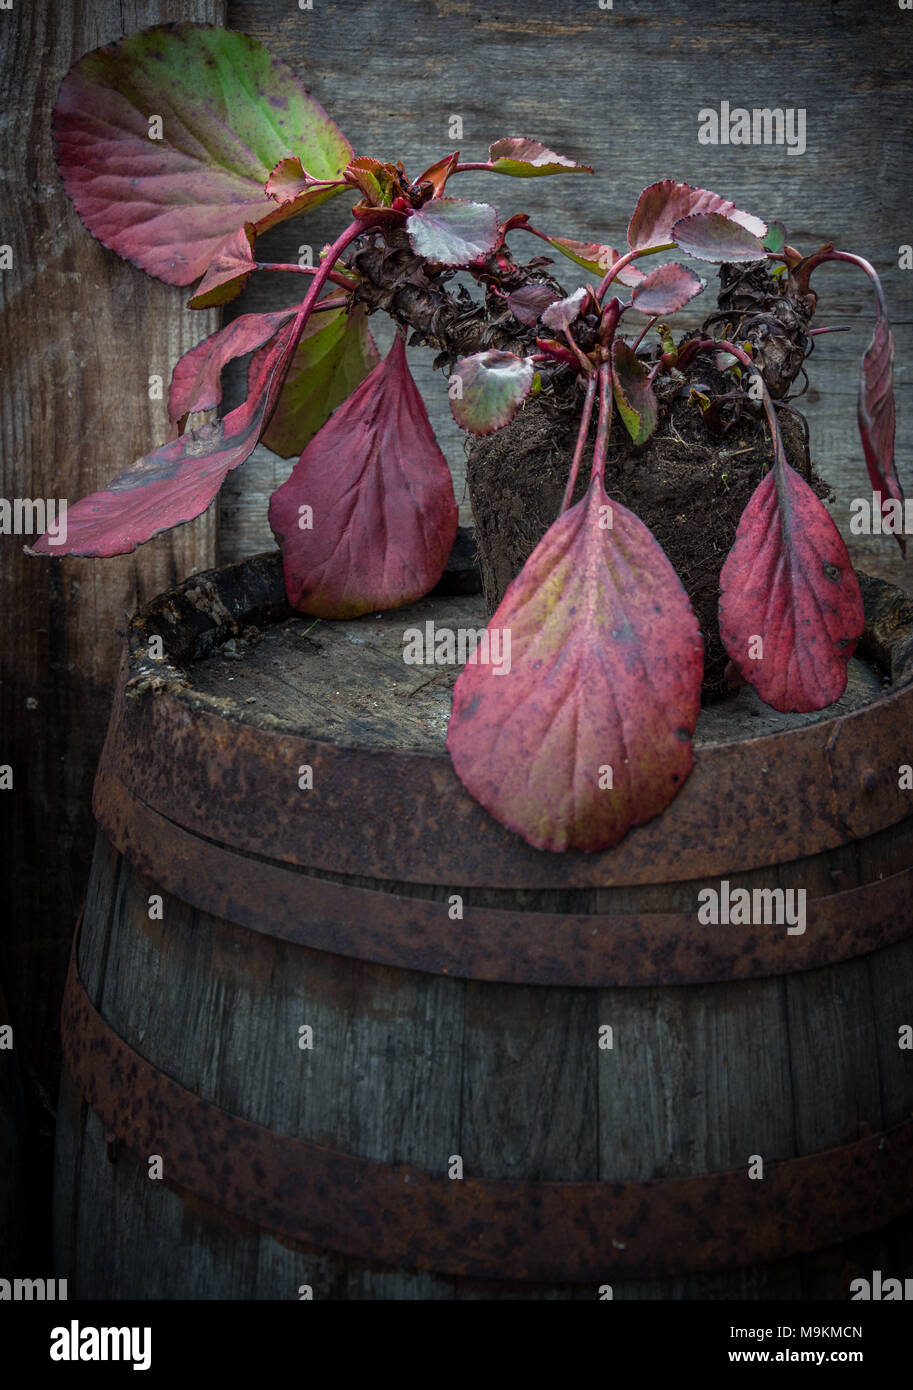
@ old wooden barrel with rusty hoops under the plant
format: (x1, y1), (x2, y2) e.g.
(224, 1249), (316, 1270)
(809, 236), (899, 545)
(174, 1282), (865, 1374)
(56, 556), (913, 1300)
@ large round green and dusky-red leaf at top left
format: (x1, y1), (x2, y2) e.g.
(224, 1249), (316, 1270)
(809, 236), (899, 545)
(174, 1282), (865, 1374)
(54, 24), (352, 285)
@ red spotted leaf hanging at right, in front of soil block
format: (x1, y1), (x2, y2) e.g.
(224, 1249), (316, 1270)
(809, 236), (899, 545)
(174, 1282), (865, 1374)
(720, 461), (864, 713)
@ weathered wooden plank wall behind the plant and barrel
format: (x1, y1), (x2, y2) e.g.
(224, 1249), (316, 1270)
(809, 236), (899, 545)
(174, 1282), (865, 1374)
(0, 0), (913, 1275)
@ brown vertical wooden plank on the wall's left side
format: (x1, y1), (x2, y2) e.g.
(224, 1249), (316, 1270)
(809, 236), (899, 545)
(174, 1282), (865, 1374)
(0, 0), (224, 1268)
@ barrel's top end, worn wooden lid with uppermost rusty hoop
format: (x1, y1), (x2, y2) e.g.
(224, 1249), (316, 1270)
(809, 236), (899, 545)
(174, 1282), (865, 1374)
(96, 553), (913, 888)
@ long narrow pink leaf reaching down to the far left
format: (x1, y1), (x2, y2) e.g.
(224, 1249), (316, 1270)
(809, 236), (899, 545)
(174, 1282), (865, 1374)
(33, 322), (295, 556)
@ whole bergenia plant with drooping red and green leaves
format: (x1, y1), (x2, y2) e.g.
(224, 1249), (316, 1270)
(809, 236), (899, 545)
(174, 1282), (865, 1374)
(33, 25), (903, 851)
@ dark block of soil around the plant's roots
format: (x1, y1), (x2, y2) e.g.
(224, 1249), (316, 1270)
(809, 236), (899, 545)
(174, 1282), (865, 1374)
(467, 361), (831, 703)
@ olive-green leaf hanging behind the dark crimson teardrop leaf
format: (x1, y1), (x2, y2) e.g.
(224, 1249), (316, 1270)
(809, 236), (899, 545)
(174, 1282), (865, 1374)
(263, 304), (381, 459)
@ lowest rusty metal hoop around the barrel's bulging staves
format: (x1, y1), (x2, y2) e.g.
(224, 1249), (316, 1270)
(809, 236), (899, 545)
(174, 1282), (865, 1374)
(61, 942), (913, 1283)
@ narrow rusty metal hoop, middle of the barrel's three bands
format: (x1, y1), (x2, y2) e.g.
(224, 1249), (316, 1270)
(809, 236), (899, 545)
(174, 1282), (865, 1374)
(96, 759), (913, 988)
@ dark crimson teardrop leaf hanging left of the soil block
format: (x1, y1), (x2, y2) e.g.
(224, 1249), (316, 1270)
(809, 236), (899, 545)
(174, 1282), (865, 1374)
(270, 335), (457, 619)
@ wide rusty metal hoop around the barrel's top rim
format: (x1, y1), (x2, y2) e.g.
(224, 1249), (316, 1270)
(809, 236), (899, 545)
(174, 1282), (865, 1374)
(108, 661), (913, 890)
